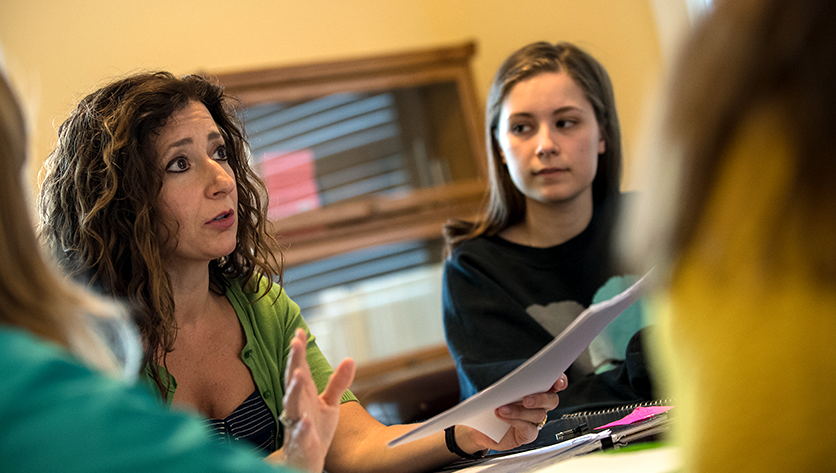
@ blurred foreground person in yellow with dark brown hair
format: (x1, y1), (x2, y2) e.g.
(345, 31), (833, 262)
(625, 0), (836, 473)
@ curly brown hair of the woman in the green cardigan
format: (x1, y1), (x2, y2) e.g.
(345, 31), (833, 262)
(38, 72), (281, 395)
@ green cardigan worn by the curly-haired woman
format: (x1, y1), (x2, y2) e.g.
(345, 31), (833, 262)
(148, 278), (357, 447)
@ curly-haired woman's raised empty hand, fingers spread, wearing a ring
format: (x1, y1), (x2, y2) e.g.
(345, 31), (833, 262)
(269, 329), (354, 473)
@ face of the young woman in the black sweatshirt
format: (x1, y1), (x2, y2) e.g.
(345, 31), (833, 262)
(496, 72), (606, 204)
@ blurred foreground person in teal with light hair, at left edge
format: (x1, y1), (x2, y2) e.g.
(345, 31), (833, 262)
(0, 59), (298, 473)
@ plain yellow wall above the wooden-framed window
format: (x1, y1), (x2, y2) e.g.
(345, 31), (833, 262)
(0, 0), (666, 184)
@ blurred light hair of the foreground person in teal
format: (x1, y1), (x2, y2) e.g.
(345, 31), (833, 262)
(0, 63), (140, 376)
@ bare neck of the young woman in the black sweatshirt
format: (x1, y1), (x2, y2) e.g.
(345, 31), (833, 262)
(500, 195), (593, 248)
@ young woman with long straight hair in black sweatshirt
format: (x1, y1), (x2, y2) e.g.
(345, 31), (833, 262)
(443, 42), (652, 414)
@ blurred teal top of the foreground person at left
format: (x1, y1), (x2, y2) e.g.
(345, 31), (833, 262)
(0, 326), (288, 473)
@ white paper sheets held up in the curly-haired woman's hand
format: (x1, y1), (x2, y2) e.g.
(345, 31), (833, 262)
(389, 275), (647, 447)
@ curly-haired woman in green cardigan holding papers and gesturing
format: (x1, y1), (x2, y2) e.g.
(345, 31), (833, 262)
(40, 72), (564, 471)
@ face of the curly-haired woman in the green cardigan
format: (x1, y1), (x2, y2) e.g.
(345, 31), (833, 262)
(154, 102), (238, 267)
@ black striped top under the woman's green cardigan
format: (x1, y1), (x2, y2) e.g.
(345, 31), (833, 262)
(207, 389), (277, 456)
